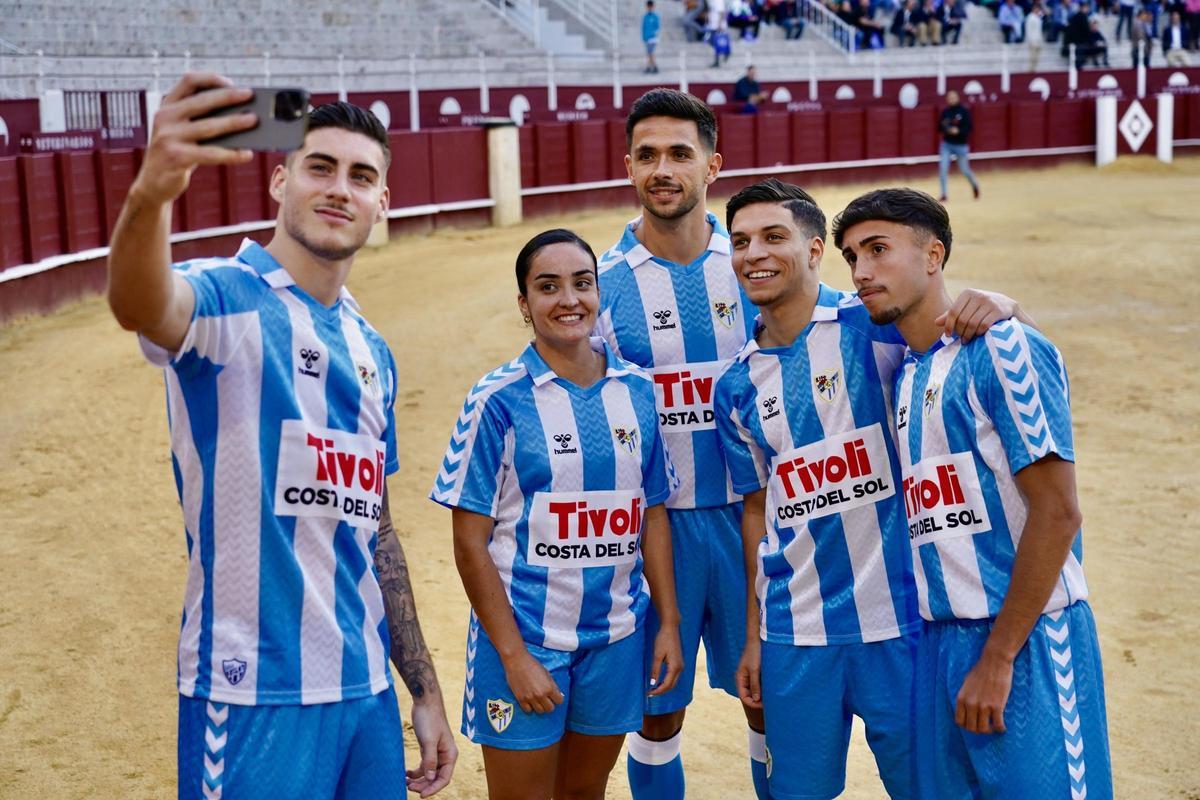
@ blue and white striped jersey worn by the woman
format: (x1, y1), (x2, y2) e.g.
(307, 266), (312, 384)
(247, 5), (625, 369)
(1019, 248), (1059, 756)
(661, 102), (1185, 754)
(430, 338), (671, 651)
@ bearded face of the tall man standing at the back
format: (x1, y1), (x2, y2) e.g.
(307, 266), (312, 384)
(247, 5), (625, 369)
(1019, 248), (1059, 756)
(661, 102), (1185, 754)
(625, 116), (721, 219)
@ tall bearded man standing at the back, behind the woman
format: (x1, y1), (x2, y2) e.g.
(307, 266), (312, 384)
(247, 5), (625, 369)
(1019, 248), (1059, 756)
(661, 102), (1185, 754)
(596, 89), (767, 800)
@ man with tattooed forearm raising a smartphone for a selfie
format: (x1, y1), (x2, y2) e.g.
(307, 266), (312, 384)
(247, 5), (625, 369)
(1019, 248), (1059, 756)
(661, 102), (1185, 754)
(108, 74), (457, 800)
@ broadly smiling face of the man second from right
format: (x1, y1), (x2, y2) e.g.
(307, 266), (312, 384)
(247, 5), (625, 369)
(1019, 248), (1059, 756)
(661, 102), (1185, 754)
(730, 203), (824, 308)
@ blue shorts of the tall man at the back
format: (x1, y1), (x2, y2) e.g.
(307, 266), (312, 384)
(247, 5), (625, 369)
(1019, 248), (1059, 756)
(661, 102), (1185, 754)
(646, 503), (746, 715)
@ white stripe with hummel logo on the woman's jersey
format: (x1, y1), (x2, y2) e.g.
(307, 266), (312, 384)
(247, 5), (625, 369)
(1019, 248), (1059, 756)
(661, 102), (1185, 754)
(533, 383), (583, 650)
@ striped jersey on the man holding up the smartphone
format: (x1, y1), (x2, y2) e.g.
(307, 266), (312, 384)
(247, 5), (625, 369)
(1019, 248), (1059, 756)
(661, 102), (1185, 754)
(142, 241), (398, 705)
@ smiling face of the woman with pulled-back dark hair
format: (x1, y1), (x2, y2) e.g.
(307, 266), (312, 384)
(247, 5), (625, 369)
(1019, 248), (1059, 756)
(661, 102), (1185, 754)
(517, 242), (600, 349)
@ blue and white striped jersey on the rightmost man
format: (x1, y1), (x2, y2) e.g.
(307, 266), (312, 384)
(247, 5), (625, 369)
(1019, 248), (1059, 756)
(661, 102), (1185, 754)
(895, 320), (1087, 620)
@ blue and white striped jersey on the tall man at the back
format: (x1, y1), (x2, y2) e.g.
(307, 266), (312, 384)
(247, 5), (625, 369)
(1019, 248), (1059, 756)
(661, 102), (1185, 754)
(596, 213), (757, 509)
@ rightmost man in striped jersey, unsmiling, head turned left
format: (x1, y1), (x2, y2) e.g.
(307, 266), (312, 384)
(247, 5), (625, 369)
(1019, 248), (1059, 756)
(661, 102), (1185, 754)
(834, 190), (1112, 800)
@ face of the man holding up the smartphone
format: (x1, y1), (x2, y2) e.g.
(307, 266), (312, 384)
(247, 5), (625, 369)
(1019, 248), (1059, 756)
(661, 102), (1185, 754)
(271, 127), (388, 261)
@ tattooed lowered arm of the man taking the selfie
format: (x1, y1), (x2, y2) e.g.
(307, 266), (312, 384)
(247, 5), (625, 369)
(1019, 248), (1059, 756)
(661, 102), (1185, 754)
(374, 486), (458, 798)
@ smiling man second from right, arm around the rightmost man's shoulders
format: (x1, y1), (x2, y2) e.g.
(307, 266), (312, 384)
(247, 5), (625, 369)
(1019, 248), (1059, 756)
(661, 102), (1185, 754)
(714, 179), (1015, 798)
